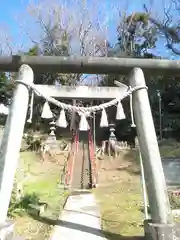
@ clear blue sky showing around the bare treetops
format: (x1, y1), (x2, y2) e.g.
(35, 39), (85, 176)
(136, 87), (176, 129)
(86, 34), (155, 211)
(0, 0), (177, 56)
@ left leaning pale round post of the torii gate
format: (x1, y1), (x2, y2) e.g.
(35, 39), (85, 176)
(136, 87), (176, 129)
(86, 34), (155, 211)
(0, 65), (33, 223)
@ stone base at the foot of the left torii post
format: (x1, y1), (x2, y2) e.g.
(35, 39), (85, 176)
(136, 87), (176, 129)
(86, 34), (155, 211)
(0, 220), (14, 240)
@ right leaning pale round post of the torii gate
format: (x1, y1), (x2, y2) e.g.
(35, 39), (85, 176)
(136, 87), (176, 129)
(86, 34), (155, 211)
(129, 68), (173, 224)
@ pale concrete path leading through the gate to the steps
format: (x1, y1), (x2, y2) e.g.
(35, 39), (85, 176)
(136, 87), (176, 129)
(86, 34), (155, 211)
(50, 192), (106, 240)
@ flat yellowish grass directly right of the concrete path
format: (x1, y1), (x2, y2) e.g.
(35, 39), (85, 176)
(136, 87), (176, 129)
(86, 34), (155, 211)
(95, 175), (143, 240)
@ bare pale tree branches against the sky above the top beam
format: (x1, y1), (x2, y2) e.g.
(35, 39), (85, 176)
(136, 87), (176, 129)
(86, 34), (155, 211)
(21, 0), (117, 78)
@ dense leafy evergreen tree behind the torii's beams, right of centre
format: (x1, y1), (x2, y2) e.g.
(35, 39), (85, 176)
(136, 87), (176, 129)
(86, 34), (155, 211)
(101, 12), (157, 86)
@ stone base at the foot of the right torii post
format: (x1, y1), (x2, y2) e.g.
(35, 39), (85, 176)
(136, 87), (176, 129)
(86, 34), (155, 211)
(144, 220), (180, 240)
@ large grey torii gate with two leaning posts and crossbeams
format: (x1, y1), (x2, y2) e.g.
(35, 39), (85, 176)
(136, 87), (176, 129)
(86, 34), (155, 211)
(0, 56), (180, 239)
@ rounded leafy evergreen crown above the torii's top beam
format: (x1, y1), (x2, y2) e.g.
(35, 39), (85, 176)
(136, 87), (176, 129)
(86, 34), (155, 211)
(114, 12), (157, 57)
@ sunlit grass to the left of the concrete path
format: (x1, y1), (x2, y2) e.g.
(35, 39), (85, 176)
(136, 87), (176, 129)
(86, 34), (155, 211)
(11, 152), (67, 240)
